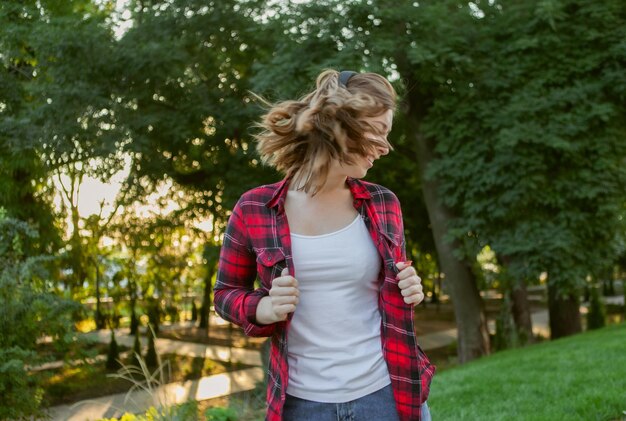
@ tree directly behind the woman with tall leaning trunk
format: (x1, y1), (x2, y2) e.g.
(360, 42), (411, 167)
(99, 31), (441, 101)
(254, 0), (489, 362)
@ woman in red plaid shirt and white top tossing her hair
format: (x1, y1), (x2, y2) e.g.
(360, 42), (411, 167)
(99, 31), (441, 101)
(215, 70), (435, 421)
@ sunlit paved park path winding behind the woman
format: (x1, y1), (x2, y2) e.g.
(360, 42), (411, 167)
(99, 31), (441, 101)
(49, 310), (549, 421)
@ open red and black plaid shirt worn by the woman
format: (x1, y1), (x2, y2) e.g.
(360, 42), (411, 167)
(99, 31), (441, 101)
(215, 178), (435, 421)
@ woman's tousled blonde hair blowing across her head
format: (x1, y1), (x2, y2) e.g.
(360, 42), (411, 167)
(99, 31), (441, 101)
(255, 70), (396, 194)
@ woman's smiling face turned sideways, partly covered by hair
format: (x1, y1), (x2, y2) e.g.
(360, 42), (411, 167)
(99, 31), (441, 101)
(330, 110), (393, 178)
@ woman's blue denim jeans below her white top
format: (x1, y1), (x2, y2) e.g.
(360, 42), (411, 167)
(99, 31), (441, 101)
(283, 385), (431, 421)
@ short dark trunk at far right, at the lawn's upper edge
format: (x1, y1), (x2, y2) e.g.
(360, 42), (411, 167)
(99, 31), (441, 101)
(548, 285), (582, 339)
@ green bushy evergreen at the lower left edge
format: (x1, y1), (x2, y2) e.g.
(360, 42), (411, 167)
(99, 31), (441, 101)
(0, 209), (78, 419)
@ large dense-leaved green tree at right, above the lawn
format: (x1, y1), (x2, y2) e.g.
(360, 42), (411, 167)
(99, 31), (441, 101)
(427, 0), (626, 338)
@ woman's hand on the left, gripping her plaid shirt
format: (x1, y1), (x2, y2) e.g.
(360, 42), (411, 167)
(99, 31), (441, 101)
(256, 268), (300, 325)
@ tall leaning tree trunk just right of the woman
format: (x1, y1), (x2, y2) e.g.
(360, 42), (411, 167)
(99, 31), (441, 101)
(408, 120), (489, 364)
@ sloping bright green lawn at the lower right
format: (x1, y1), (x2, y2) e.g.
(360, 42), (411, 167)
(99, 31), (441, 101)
(428, 323), (626, 421)
